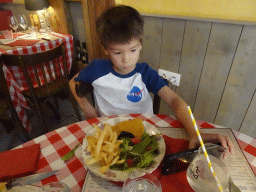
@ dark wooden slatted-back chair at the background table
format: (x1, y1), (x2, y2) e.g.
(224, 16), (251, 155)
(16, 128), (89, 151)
(0, 44), (82, 132)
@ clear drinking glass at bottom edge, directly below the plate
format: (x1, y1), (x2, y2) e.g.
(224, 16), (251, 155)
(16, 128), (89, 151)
(122, 174), (162, 192)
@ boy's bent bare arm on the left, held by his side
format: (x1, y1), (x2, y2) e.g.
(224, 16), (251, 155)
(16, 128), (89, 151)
(69, 74), (98, 119)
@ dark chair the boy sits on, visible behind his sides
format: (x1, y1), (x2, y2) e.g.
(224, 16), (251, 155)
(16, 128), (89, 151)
(75, 81), (168, 114)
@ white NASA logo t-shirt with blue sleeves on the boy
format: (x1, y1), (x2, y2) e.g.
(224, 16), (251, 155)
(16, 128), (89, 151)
(75, 60), (167, 116)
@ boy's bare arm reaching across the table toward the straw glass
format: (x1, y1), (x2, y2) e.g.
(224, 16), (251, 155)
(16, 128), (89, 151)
(158, 86), (234, 153)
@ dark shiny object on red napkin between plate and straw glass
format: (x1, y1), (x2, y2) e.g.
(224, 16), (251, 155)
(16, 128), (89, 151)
(161, 142), (221, 175)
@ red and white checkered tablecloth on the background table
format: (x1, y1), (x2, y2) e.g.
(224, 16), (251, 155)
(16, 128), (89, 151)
(0, 33), (73, 131)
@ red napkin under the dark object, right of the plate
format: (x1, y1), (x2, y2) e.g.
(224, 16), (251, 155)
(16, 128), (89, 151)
(113, 135), (194, 192)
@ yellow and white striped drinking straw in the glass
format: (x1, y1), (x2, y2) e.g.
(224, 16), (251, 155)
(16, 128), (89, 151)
(188, 106), (223, 192)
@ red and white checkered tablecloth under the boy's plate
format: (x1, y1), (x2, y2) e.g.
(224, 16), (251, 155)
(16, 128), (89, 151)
(14, 115), (256, 192)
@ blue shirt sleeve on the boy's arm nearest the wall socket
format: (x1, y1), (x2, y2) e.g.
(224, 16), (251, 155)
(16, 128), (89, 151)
(140, 63), (168, 94)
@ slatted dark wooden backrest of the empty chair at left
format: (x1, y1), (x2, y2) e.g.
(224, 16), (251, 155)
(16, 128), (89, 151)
(0, 44), (69, 99)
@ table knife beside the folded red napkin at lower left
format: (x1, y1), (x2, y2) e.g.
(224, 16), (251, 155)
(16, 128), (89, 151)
(7, 170), (59, 190)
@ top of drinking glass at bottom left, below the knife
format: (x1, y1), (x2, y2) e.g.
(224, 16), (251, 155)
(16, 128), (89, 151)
(38, 182), (71, 192)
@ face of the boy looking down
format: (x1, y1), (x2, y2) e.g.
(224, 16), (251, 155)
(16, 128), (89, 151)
(105, 39), (142, 75)
